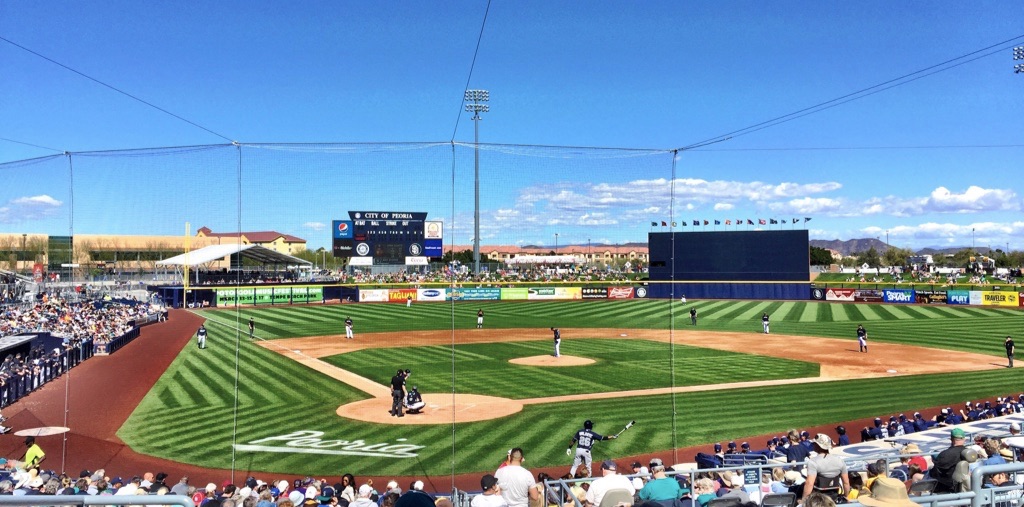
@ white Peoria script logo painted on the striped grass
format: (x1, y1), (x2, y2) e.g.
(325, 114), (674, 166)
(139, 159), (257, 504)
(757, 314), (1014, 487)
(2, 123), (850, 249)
(234, 430), (426, 458)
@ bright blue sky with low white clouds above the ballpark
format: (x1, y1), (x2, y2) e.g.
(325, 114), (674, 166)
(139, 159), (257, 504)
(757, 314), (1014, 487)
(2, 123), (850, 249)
(0, 0), (1024, 250)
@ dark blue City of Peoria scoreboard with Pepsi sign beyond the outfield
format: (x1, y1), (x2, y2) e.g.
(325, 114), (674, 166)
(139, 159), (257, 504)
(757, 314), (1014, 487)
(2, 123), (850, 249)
(332, 211), (444, 265)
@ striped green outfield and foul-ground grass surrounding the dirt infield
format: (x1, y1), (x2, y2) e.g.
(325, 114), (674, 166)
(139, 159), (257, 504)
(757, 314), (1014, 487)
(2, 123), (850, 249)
(118, 300), (1024, 476)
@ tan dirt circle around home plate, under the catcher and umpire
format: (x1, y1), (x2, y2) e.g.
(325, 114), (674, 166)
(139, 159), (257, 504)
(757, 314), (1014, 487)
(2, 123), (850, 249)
(337, 392), (522, 424)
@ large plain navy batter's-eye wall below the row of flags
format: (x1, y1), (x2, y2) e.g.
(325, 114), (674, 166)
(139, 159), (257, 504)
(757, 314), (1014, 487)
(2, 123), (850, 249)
(647, 229), (811, 299)
